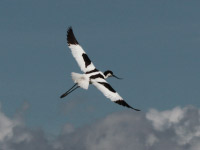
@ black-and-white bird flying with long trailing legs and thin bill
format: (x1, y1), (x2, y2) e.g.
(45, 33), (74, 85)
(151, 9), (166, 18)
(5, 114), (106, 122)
(60, 27), (140, 111)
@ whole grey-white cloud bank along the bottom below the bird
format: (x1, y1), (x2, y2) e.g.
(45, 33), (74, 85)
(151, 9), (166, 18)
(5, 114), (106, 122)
(0, 106), (200, 150)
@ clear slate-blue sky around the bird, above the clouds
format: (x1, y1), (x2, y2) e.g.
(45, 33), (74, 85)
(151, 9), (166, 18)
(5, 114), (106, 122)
(0, 0), (200, 138)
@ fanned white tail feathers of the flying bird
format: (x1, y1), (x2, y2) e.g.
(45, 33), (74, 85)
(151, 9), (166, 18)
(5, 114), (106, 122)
(71, 72), (89, 90)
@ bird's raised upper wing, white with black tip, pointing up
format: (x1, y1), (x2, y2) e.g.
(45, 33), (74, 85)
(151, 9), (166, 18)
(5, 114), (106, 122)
(67, 27), (95, 73)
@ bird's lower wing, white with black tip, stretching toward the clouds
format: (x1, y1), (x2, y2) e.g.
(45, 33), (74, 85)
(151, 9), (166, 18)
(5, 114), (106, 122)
(92, 79), (140, 111)
